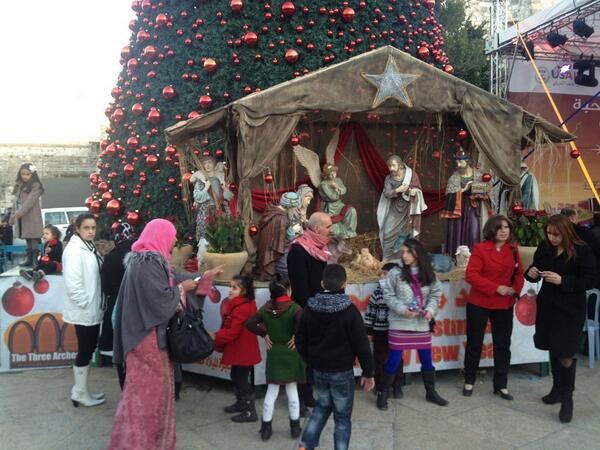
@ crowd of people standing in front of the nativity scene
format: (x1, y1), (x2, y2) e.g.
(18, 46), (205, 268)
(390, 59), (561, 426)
(2, 165), (597, 449)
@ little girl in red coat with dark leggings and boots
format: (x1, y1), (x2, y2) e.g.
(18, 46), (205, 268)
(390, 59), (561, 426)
(215, 275), (260, 422)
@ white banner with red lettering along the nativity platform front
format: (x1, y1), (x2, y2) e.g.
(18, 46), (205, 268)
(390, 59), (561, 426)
(184, 281), (548, 384)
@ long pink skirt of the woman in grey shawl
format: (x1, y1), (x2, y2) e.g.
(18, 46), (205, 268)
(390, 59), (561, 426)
(108, 330), (175, 450)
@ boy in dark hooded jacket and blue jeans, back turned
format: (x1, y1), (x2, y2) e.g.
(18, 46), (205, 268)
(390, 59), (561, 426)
(296, 264), (375, 450)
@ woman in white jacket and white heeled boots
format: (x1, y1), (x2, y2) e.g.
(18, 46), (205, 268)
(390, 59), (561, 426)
(63, 214), (104, 406)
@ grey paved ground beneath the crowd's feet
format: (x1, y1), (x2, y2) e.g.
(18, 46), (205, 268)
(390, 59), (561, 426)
(0, 358), (600, 450)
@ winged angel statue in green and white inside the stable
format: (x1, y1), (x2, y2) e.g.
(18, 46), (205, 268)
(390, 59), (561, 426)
(294, 130), (357, 239)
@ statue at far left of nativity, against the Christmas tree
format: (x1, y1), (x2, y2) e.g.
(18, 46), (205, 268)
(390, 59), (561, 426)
(190, 156), (233, 255)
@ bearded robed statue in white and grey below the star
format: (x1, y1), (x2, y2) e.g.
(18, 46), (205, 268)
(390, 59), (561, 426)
(377, 155), (427, 260)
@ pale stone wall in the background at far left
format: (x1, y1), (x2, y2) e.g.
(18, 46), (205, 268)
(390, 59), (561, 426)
(0, 142), (99, 211)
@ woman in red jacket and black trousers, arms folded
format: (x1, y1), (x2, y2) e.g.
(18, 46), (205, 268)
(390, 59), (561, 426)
(463, 215), (524, 400)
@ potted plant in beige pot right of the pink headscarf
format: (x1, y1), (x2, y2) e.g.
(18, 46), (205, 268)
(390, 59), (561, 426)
(202, 211), (248, 281)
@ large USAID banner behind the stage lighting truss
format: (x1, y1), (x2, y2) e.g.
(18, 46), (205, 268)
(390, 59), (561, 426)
(508, 60), (600, 208)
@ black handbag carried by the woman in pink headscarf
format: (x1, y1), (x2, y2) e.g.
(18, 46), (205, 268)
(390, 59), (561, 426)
(167, 300), (215, 364)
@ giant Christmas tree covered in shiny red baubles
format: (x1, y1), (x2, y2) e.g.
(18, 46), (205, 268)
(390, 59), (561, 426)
(86, 0), (452, 241)
